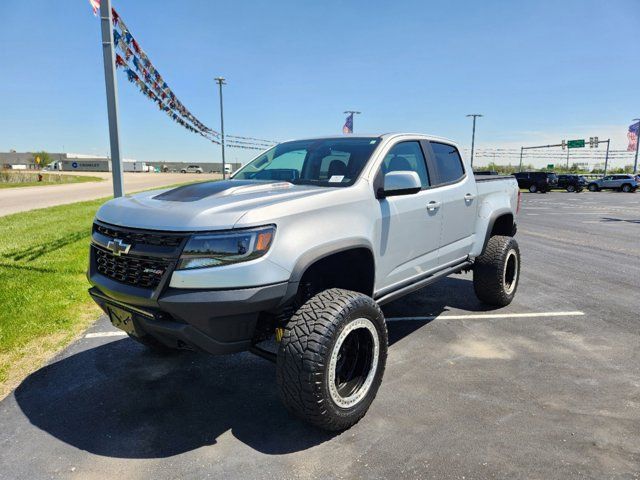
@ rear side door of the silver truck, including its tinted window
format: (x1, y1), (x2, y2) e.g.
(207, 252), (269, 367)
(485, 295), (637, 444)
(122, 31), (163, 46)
(424, 142), (478, 266)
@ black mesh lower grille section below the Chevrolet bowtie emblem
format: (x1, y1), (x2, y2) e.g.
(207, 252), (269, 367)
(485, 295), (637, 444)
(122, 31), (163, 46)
(93, 245), (169, 289)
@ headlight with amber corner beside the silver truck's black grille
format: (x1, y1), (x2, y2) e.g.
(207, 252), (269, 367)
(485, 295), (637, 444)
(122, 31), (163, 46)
(177, 226), (276, 270)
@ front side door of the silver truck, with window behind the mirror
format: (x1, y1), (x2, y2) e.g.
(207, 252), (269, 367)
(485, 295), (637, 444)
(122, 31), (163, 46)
(376, 141), (442, 290)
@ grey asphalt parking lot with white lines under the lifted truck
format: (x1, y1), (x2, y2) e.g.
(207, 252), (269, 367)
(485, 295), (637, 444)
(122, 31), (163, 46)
(0, 192), (640, 480)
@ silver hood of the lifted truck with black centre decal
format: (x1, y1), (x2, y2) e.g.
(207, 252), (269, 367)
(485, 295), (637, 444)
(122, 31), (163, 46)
(96, 180), (335, 231)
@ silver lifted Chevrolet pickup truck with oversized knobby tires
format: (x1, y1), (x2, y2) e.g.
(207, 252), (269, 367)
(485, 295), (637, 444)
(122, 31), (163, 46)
(88, 134), (520, 430)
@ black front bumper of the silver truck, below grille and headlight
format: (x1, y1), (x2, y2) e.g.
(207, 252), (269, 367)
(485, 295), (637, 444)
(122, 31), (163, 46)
(89, 282), (289, 355)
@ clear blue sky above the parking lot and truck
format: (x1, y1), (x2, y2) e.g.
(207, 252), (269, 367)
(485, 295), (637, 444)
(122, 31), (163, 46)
(0, 0), (640, 167)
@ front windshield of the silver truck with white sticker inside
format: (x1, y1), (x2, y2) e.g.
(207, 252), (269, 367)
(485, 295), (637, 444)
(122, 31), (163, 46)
(233, 137), (380, 187)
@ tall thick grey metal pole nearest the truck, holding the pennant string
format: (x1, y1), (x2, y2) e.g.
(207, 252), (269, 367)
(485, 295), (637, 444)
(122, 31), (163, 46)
(100, 0), (124, 197)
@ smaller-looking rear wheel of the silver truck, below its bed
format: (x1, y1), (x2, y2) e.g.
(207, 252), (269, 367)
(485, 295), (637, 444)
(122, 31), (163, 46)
(473, 235), (520, 307)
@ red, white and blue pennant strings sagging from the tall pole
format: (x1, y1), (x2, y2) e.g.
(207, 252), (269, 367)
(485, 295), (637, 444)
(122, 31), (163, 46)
(89, 0), (277, 150)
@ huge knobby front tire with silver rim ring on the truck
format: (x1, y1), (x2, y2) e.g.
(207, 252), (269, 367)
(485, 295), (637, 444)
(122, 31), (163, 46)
(276, 288), (388, 431)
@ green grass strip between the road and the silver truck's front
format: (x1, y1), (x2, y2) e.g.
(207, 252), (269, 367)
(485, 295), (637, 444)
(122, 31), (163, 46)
(0, 199), (106, 398)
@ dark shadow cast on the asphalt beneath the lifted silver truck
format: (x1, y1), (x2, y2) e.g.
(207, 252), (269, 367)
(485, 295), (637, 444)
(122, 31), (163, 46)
(14, 278), (492, 458)
